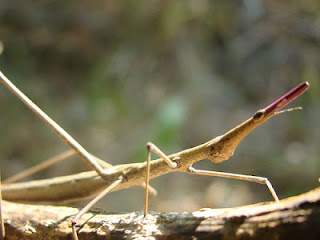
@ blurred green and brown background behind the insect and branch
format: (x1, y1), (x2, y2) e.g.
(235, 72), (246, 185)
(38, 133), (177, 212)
(0, 0), (320, 211)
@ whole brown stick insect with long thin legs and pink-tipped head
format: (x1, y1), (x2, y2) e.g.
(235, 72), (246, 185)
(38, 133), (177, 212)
(0, 72), (309, 240)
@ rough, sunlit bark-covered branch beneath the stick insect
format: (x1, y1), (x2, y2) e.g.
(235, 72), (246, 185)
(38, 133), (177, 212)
(2, 188), (320, 240)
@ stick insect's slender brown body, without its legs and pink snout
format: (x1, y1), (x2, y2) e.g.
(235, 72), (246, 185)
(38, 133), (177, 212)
(2, 111), (288, 203)
